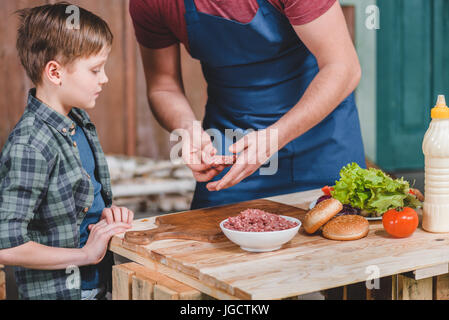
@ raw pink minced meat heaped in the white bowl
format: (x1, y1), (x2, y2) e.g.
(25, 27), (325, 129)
(223, 209), (298, 232)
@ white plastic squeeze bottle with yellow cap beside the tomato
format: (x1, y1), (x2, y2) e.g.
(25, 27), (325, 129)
(422, 95), (449, 233)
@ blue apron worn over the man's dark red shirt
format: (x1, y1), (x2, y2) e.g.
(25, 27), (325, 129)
(184, 0), (366, 209)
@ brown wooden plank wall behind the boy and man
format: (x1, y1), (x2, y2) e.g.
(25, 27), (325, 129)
(0, 0), (354, 159)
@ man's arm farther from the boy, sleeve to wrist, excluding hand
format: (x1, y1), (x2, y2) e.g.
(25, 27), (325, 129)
(272, 1), (361, 148)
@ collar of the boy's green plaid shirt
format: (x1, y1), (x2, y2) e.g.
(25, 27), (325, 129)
(27, 88), (93, 135)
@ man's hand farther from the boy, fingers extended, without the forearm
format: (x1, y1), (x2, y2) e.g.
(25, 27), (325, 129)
(207, 129), (279, 191)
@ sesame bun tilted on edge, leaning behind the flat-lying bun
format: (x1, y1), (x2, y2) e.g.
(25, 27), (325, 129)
(303, 198), (343, 233)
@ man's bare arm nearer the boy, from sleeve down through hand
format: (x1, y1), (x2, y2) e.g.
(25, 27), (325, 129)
(140, 44), (226, 182)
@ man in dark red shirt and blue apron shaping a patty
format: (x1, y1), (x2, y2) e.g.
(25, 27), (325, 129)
(130, 0), (365, 209)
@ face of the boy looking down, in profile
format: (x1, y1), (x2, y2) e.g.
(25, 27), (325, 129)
(60, 48), (110, 109)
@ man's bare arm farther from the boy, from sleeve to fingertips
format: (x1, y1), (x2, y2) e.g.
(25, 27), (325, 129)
(207, 1), (361, 191)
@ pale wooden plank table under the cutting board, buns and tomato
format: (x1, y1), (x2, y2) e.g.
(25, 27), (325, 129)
(110, 190), (449, 299)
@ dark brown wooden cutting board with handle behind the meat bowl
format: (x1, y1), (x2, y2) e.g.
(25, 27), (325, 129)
(125, 199), (307, 245)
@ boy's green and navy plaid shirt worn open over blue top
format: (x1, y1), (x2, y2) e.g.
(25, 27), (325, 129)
(0, 89), (112, 300)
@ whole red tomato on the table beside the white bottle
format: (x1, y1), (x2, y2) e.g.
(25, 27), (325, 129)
(382, 207), (419, 238)
